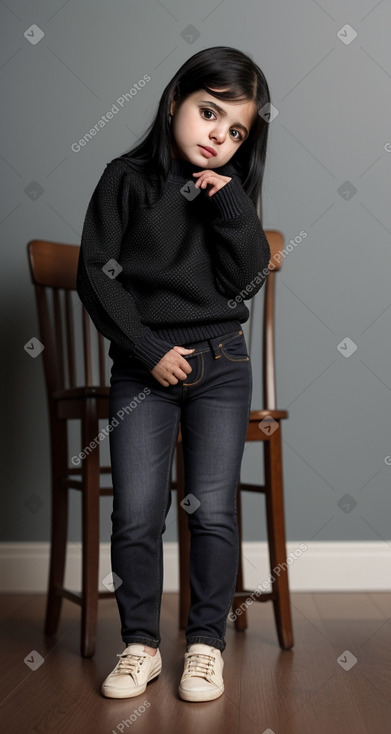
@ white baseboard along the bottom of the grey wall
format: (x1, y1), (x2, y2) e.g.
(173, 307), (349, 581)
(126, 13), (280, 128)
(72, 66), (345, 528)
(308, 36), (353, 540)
(0, 541), (391, 594)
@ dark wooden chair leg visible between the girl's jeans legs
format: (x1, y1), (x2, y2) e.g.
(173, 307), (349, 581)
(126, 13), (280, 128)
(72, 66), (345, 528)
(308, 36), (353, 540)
(175, 441), (191, 629)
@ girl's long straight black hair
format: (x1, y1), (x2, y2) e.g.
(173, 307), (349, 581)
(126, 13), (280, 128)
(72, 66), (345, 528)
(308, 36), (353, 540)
(122, 46), (270, 206)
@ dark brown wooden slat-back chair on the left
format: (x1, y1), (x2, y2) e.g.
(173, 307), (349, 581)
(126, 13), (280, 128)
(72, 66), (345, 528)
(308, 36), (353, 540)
(27, 240), (114, 657)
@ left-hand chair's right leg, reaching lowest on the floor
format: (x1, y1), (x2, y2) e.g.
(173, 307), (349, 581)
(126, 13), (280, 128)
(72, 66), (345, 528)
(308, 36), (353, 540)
(80, 406), (100, 658)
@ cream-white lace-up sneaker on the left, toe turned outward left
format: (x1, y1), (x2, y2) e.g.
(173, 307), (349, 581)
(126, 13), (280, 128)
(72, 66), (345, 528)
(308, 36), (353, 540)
(101, 643), (162, 698)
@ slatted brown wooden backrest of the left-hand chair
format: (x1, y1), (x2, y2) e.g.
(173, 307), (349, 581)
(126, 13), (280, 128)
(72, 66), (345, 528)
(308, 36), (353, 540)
(27, 240), (108, 399)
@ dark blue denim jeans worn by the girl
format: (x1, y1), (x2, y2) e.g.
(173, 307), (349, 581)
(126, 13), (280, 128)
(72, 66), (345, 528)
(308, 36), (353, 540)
(109, 331), (252, 651)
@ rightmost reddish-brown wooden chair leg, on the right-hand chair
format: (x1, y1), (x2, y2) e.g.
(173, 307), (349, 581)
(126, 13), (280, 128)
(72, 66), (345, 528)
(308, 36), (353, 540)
(264, 432), (294, 650)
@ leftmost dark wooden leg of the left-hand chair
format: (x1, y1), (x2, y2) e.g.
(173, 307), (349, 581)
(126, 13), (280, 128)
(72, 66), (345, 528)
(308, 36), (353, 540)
(44, 419), (68, 636)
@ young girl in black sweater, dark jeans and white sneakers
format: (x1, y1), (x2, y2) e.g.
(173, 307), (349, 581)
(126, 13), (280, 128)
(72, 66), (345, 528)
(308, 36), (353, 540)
(77, 46), (270, 701)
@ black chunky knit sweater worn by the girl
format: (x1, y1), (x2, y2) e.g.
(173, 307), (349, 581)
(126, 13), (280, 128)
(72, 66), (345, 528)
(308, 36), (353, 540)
(76, 153), (270, 370)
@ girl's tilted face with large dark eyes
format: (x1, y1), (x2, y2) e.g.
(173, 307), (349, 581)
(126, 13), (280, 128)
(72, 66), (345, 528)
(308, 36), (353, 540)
(170, 89), (257, 169)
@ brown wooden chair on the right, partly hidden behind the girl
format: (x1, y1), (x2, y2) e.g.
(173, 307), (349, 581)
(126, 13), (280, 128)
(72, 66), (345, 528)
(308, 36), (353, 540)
(175, 230), (293, 650)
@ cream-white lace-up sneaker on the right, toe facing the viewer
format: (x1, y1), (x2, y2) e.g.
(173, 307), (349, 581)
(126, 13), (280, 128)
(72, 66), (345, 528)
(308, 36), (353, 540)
(178, 643), (224, 701)
